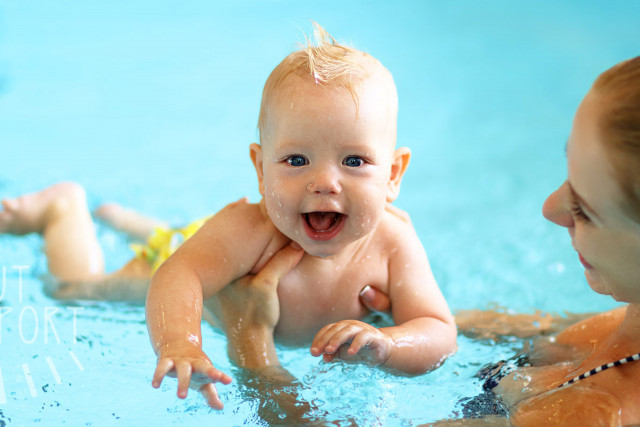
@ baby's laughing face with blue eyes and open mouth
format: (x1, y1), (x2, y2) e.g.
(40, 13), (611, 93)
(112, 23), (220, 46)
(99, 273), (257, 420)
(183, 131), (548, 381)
(256, 76), (396, 257)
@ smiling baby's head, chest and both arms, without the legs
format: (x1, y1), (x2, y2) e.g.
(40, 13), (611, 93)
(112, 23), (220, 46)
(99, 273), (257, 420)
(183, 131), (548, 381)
(146, 25), (456, 408)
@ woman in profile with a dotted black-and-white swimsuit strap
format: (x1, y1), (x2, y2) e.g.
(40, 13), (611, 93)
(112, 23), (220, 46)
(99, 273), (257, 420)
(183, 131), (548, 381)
(230, 57), (640, 426)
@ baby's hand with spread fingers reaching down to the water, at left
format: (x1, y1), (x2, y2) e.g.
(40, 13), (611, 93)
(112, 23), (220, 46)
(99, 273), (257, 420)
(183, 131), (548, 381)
(151, 345), (231, 409)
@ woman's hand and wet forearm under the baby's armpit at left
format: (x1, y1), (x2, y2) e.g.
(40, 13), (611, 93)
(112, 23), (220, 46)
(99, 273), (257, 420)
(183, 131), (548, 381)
(215, 243), (312, 425)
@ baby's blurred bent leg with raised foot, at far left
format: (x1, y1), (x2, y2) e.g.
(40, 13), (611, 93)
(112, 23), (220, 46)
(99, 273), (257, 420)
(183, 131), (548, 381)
(0, 182), (151, 300)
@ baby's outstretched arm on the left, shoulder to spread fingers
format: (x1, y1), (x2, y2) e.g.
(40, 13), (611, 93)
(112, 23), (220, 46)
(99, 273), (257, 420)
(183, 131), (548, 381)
(146, 204), (272, 409)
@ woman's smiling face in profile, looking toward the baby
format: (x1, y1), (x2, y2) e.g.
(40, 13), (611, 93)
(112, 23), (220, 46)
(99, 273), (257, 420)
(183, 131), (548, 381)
(543, 92), (640, 303)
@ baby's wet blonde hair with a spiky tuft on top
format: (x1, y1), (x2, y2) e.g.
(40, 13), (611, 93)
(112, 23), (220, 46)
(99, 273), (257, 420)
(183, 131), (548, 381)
(258, 22), (397, 142)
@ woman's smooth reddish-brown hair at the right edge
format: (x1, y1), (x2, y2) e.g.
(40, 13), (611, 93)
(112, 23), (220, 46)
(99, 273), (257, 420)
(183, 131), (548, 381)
(592, 56), (640, 223)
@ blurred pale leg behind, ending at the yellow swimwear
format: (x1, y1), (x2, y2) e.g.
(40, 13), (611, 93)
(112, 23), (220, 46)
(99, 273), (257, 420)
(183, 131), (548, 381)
(93, 203), (167, 241)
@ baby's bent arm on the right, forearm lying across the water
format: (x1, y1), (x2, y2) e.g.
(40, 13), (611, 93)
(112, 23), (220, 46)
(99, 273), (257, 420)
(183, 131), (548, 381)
(311, 214), (456, 374)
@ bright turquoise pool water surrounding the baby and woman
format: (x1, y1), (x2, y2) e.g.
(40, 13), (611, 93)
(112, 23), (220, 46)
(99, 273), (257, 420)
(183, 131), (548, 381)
(0, 0), (640, 426)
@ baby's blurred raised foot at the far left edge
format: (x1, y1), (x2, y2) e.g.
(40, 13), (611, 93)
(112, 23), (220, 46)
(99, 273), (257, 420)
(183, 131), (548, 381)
(0, 182), (86, 235)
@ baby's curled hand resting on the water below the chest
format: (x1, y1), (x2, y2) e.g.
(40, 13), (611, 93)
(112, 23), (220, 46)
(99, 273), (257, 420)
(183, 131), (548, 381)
(311, 320), (392, 366)
